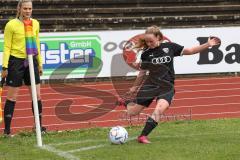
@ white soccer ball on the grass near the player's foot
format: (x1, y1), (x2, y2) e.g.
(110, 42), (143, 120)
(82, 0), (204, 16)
(109, 126), (128, 144)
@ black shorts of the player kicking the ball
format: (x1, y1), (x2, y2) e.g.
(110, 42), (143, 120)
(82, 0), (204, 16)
(134, 81), (175, 107)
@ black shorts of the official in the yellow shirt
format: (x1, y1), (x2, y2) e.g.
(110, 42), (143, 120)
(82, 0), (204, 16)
(6, 56), (40, 87)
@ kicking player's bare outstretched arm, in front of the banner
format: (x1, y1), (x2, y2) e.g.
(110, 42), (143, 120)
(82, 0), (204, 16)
(183, 37), (221, 55)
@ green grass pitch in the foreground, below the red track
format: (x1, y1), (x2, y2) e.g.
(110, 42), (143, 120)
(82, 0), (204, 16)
(0, 119), (240, 160)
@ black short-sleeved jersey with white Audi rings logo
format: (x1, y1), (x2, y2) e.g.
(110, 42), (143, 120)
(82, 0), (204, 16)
(141, 42), (184, 84)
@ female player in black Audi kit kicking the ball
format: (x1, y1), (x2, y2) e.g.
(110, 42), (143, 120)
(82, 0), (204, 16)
(125, 26), (221, 144)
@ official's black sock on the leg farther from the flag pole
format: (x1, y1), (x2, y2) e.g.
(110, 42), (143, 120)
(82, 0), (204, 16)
(4, 99), (16, 134)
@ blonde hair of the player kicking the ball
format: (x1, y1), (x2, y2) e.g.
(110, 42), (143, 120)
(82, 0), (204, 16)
(134, 25), (163, 48)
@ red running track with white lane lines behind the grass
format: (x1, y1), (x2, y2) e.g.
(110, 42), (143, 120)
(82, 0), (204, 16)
(0, 77), (240, 132)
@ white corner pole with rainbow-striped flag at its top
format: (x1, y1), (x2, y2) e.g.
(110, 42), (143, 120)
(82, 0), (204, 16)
(24, 20), (43, 147)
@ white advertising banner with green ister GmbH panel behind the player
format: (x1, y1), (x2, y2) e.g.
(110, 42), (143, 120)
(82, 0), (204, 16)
(0, 27), (240, 79)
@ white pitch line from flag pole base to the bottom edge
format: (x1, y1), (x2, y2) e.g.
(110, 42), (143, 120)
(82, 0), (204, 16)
(41, 145), (80, 160)
